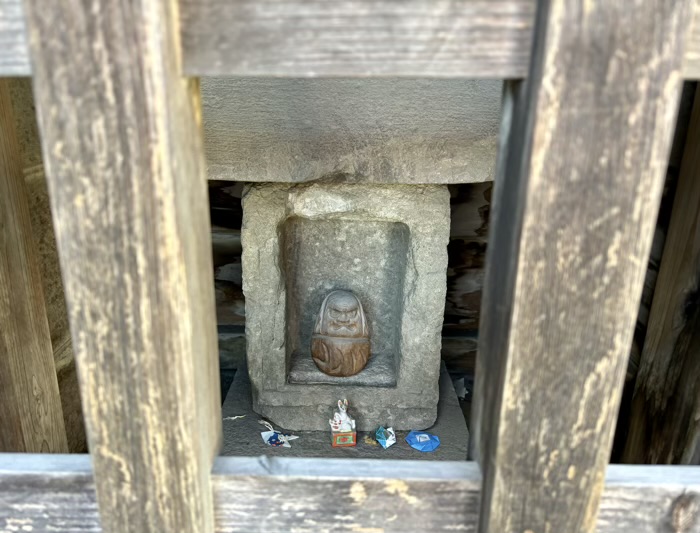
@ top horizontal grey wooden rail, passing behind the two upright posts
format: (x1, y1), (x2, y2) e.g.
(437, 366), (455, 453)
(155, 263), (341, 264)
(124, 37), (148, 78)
(0, 0), (700, 79)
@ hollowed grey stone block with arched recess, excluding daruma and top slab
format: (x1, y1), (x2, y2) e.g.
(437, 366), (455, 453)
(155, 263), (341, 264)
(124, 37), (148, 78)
(241, 184), (450, 431)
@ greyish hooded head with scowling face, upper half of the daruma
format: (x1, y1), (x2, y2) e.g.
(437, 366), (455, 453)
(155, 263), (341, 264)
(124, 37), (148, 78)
(314, 290), (369, 337)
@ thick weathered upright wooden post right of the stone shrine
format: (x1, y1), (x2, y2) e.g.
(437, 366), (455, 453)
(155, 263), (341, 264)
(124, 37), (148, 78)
(473, 0), (691, 532)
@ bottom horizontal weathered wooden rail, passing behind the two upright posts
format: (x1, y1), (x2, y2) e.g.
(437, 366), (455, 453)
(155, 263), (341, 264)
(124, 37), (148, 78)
(0, 454), (700, 533)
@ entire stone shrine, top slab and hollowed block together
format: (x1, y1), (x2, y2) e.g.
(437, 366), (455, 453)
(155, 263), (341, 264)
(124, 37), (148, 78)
(202, 78), (501, 432)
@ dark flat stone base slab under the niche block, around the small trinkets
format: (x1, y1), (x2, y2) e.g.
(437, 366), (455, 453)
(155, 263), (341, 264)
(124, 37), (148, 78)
(221, 366), (469, 461)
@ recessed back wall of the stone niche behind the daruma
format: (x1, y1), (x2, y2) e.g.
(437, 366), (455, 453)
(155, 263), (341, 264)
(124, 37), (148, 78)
(282, 217), (409, 382)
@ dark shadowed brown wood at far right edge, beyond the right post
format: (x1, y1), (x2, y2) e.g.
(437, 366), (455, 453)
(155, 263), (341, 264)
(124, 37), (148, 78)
(623, 86), (700, 464)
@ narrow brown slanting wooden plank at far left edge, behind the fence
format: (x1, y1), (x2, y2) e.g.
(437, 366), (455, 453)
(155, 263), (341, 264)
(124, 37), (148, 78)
(0, 79), (68, 453)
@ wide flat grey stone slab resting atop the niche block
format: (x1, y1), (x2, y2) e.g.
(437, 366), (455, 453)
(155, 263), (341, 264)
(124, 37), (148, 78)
(202, 78), (501, 183)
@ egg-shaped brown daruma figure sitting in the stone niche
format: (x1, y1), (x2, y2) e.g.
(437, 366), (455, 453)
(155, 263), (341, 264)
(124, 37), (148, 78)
(311, 291), (370, 377)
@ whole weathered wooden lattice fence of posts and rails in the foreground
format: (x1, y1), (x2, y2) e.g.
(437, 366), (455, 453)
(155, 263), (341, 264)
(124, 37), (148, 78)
(0, 0), (700, 533)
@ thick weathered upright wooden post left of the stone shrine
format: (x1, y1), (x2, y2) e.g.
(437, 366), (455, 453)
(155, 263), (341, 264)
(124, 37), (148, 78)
(25, 0), (221, 533)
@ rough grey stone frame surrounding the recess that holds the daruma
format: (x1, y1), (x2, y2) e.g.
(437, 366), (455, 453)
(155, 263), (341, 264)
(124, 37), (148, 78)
(241, 184), (450, 431)
